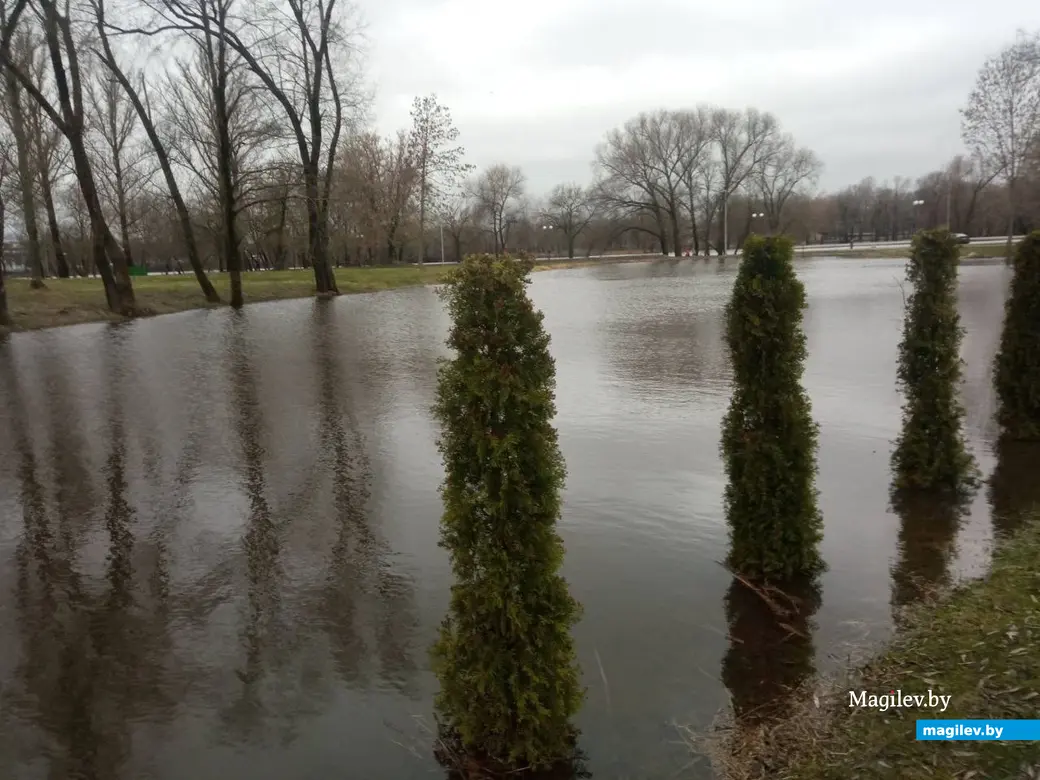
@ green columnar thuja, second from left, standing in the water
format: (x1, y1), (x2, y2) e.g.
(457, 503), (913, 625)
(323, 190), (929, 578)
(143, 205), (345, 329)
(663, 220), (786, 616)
(722, 236), (823, 581)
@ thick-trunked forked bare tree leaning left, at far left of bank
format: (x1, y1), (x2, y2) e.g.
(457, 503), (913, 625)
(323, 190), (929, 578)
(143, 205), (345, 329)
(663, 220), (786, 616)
(0, 0), (135, 315)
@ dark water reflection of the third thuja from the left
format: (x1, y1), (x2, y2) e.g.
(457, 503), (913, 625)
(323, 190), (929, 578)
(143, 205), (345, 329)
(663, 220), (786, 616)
(891, 493), (965, 620)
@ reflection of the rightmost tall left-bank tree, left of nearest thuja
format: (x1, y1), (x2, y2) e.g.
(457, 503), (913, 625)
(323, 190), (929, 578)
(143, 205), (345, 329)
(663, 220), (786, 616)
(314, 305), (417, 688)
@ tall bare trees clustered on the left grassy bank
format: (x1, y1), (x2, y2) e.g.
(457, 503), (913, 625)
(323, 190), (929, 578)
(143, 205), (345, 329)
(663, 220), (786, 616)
(0, 0), (367, 314)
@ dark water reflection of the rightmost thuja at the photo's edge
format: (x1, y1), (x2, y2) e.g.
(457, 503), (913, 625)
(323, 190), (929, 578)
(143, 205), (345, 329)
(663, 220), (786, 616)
(989, 437), (1040, 539)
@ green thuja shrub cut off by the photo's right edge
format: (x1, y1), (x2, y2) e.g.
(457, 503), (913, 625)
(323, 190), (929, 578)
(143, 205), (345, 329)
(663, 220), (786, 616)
(993, 231), (1040, 440)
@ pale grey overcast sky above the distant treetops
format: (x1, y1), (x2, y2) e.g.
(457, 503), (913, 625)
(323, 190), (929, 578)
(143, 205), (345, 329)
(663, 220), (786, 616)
(360, 0), (1040, 194)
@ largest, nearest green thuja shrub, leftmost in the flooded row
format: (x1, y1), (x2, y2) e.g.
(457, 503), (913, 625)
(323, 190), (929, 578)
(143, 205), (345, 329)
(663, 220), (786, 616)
(433, 255), (584, 768)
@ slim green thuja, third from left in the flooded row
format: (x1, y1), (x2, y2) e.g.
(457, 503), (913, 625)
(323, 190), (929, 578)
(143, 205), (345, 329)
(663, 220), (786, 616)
(892, 230), (977, 493)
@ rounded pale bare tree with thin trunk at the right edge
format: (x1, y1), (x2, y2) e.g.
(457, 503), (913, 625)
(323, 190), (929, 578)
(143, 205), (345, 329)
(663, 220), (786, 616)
(961, 33), (1040, 259)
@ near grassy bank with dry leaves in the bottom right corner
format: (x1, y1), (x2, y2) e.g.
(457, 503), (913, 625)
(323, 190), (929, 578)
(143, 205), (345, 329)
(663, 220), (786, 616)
(705, 520), (1040, 780)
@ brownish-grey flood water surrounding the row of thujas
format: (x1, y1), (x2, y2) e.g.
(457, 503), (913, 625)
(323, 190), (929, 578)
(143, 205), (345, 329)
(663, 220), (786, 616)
(0, 258), (1027, 780)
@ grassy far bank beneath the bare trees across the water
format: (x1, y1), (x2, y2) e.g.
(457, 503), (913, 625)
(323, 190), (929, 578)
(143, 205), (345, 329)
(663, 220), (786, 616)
(7, 257), (640, 331)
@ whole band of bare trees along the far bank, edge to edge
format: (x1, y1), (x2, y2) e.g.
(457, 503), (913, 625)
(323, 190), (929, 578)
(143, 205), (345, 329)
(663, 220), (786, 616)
(0, 0), (1040, 322)
